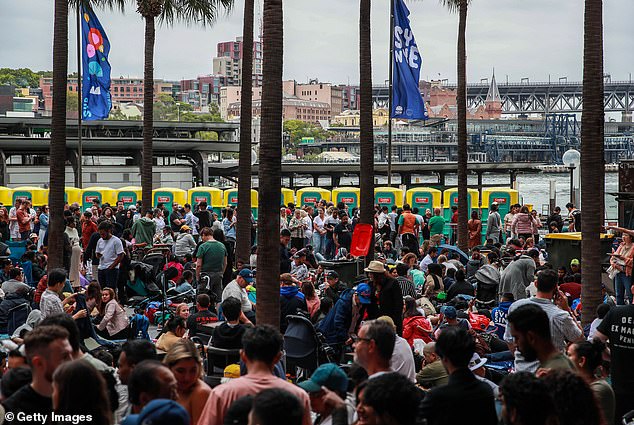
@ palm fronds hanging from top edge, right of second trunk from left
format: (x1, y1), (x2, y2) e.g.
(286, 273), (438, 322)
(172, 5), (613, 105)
(158, 0), (235, 26)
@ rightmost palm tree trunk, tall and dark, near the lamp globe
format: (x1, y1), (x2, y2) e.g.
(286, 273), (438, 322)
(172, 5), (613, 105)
(581, 0), (605, 325)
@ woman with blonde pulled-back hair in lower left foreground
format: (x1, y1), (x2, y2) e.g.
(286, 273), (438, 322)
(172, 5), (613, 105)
(163, 339), (211, 424)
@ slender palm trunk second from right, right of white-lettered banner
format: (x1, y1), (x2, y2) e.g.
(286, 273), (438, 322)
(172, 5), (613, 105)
(455, 0), (469, 251)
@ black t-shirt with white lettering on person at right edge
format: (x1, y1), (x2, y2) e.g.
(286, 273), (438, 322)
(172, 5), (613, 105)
(597, 305), (634, 392)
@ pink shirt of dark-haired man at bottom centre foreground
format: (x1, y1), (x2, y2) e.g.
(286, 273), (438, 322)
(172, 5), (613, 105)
(198, 374), (312, 425)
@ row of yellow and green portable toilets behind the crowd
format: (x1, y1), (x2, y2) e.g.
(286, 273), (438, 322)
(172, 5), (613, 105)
(0, 186), (519, 220)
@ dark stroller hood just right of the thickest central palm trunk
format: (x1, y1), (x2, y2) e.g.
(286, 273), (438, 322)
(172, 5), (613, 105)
(284, 315), (334, 379)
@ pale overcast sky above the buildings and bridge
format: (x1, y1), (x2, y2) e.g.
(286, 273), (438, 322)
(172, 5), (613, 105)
(0, 0), (634, 83)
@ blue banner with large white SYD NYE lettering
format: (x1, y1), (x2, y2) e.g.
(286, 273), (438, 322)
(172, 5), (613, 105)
(390, 0), (429, 120)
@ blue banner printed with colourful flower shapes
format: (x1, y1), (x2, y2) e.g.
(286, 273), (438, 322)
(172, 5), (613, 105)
(81, 8), (112, 120)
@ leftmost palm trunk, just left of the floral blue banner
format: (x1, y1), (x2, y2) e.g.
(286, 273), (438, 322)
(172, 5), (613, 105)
(48, 0), (68, 270)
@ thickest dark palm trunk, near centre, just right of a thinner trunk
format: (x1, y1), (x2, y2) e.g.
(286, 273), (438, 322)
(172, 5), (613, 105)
(254, 0), (284, 328)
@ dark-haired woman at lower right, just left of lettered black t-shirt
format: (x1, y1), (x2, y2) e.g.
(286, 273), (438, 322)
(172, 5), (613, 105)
(568, 339), (615, 424)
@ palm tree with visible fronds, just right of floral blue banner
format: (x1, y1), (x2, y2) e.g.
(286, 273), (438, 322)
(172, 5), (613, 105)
(137, 0), (233, 210)
